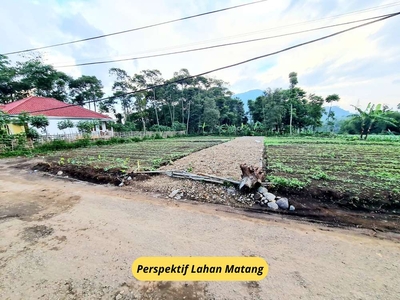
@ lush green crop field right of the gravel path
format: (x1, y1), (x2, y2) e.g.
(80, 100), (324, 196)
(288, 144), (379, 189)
(265, 137), (400, 212)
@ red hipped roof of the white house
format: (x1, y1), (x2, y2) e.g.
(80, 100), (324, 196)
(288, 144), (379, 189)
(0, 97), (111, 119)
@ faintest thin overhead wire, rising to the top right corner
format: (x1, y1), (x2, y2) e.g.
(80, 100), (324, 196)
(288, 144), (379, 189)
(42, 1), (400, 64)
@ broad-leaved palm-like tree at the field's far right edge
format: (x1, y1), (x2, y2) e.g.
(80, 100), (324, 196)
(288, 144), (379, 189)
(351, 103), (396, 140)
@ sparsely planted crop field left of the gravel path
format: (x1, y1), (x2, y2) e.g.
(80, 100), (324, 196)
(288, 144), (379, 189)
(46, 137), (230, 171)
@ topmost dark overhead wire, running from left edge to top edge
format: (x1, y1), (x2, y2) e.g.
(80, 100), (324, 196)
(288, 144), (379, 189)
(2, 0), (268, 55)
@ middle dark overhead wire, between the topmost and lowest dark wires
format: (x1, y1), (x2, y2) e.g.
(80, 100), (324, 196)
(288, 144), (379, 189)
(54, 14), (396, 68)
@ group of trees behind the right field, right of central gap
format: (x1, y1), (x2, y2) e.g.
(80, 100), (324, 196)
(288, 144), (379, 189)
(249, 72), (400, 139)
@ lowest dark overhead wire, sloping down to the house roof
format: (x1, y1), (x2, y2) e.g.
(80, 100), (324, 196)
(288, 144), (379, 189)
(27, 12), (400, 113)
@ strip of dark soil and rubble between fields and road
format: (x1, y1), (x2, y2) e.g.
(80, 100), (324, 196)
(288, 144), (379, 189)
(33, 163), (400, 232)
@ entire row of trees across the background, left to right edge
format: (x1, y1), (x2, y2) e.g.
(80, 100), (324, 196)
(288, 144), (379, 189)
(0, 55), (400, 136)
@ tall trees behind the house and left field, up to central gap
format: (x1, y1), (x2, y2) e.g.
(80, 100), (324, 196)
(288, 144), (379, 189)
(0, 56), (247, 133)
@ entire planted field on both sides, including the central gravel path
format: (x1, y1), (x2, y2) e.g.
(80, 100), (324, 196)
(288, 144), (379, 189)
(20, 136), (400, 232)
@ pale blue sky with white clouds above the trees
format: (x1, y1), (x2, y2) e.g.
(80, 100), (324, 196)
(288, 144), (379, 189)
(0, 0), (400, 109)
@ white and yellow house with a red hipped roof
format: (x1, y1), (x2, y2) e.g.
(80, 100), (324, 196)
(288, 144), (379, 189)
(0, 96), (113, 135)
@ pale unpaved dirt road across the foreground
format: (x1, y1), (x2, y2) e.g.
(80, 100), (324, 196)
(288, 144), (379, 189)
(0, 160), (400, 299)
